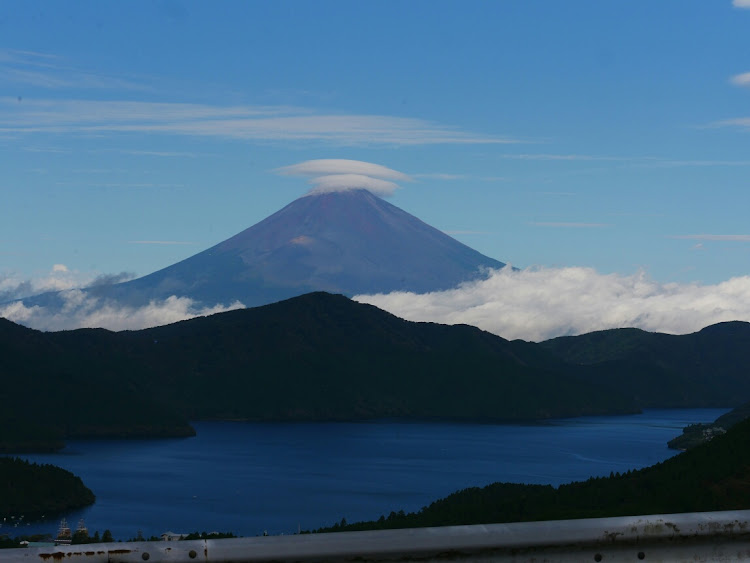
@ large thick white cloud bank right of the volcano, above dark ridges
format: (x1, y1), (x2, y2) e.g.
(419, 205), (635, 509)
(354, 267), (750, 341)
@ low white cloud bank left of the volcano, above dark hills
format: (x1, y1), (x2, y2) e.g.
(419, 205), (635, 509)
(0, 289), (244, 330)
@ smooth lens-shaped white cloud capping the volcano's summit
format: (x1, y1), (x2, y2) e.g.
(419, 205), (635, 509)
(276, 158), (411, 197)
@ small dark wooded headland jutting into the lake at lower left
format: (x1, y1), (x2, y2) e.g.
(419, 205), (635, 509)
(0, 457), (94, 520)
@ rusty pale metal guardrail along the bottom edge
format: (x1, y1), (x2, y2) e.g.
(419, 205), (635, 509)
(5, 510), (750, 563)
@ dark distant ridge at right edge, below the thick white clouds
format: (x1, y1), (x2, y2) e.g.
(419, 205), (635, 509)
(541, 322), (750, 407)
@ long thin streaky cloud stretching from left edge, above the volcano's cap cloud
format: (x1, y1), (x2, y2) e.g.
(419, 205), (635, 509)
(0, 97), (519, 145)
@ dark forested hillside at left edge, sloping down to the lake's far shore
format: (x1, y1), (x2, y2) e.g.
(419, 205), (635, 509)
(0, 321), (193, 452)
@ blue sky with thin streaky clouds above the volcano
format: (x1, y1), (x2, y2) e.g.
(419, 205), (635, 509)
(0, 0), (750, 340)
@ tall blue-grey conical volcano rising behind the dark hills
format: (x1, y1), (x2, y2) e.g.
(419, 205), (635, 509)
(24, 190), (505, 307)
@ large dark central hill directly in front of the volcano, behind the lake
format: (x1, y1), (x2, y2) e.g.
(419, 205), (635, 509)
(128, 293), (632, 421)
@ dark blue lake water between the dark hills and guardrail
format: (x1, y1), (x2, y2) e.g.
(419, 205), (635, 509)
(7, 409), (727, 539)
